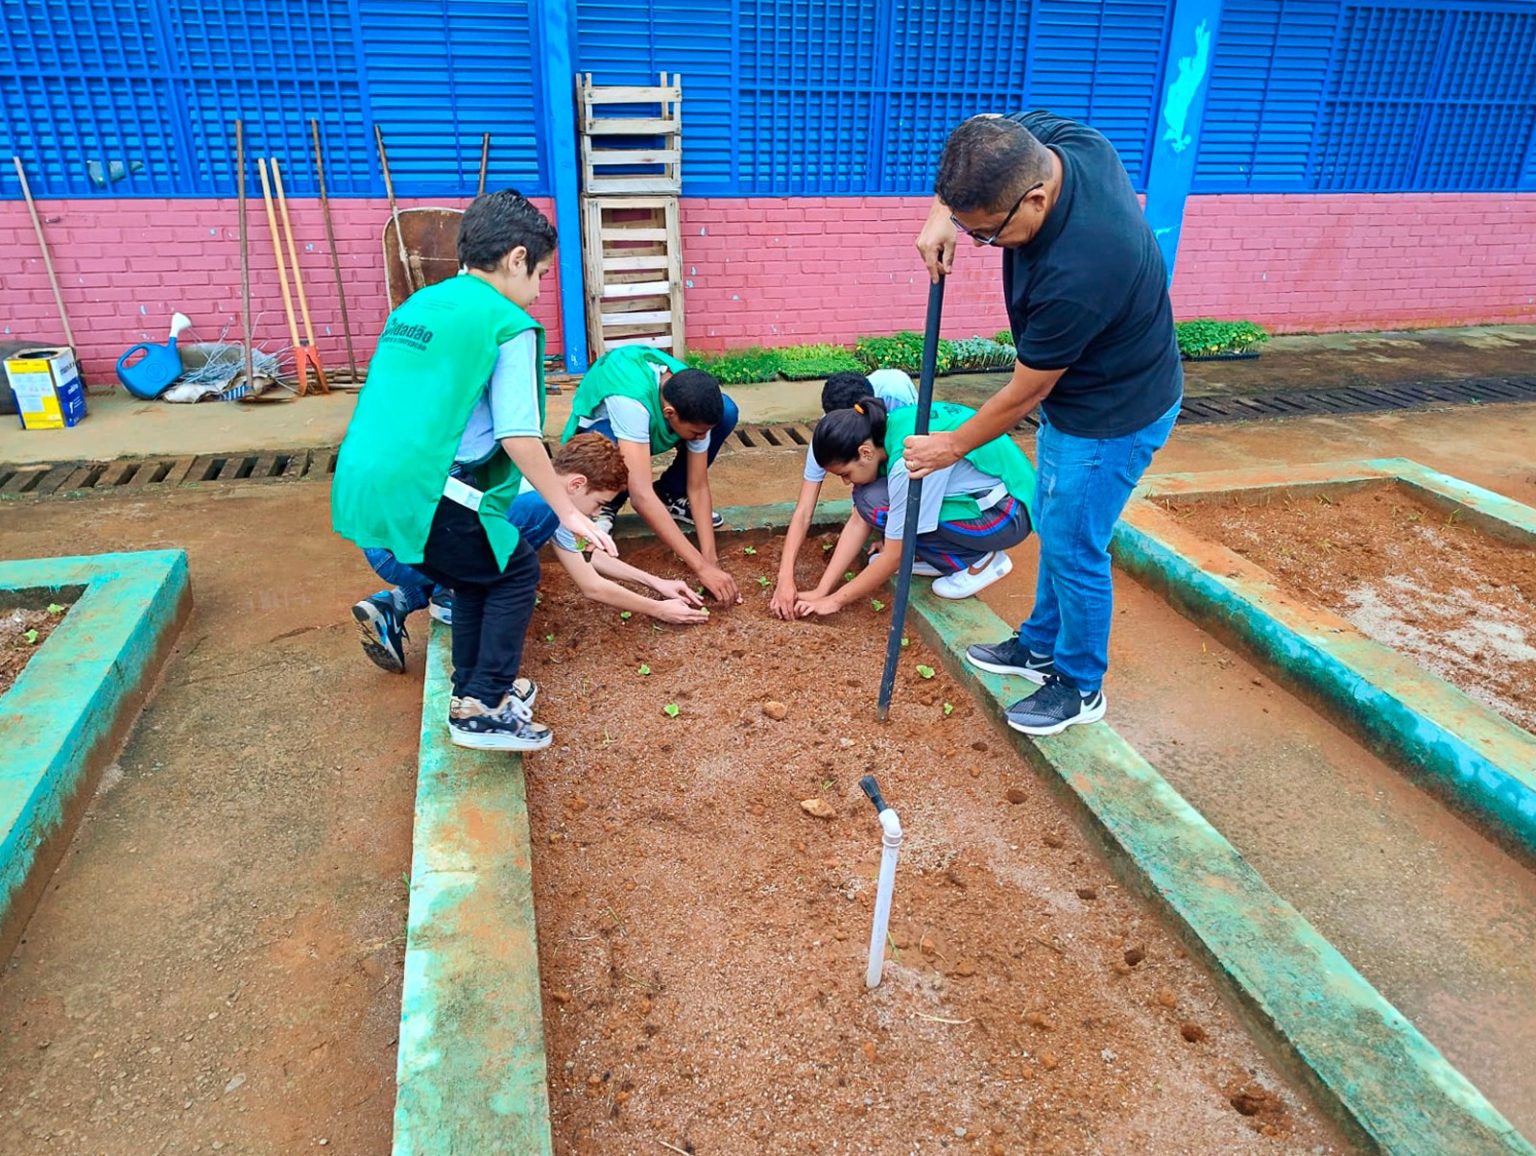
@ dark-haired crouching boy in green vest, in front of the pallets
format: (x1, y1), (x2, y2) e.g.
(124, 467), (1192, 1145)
(561, 345), (742, 605)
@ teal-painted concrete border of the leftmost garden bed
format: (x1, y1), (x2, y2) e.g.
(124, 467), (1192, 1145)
(0, 550), (190, 945)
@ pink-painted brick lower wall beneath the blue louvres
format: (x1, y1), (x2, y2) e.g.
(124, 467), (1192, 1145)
(0, 193), (1536, 384)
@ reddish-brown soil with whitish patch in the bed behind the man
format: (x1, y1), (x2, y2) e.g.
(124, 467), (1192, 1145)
(1167, 484), (1536, 731)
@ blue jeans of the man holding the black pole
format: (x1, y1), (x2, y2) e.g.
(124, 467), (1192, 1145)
(1018, 402), (1180, 694)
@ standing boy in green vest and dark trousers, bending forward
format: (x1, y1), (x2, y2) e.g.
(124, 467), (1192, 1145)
(330, 189), (616, 751)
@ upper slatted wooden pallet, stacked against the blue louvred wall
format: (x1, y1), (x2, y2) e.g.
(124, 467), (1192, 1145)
(576, 72), (682, 197)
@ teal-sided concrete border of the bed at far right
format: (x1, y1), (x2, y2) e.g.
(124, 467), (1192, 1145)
(1112, 457), (1536, 857)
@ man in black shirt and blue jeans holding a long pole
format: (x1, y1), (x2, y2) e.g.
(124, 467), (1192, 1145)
(906, 112), (1184, 735)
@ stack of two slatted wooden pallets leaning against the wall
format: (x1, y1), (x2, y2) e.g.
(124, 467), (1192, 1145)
(576, 72), (684, 358)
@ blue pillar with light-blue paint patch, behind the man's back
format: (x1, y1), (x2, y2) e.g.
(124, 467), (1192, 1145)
(1146, 0), (1221, 284)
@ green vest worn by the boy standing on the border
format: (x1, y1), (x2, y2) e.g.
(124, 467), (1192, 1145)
(330, 273), (544, 566)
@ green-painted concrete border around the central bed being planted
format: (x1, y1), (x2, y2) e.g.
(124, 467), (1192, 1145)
(393, 502), (1536, 1156)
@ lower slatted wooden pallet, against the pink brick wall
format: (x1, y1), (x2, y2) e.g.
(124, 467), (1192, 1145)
(582, 197), (684, 358)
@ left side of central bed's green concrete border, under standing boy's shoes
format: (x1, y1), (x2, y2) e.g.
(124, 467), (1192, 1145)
(393, 623), (553, 1156)
